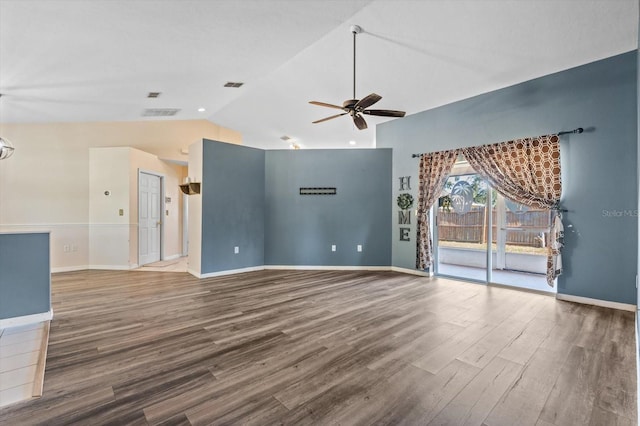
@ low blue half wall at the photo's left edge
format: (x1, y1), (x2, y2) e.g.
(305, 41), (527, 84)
(0, 233), (51, 319)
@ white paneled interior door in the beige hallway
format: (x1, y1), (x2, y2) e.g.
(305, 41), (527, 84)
(138, 172), (162, 266)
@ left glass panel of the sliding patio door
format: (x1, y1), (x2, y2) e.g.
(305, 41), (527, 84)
(434, 174), (490, 282)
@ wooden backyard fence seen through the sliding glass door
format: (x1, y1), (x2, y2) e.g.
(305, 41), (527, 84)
(438, 207), (551, 247)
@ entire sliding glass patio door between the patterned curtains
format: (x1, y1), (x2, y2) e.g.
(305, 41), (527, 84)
(434, 159), (555, 292)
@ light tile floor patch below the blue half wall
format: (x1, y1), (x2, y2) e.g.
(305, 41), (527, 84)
(0, 322), (47, 407)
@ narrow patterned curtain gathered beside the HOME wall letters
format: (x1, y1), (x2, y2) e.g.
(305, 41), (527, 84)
(416, 150), (458, 270)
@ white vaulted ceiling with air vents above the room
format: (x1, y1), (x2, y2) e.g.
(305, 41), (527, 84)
(0, 0), (638, 148)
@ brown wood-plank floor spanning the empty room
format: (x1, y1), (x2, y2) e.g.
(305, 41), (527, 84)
(0, 271), (637, 426)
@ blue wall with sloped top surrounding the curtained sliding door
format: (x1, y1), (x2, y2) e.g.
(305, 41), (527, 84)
(376, 50), (638, 304)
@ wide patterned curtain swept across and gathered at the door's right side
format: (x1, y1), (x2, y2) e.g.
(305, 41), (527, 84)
(462, 135), (562, 286)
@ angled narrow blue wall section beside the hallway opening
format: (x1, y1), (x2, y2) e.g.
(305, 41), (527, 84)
(201, 139), (265, 274)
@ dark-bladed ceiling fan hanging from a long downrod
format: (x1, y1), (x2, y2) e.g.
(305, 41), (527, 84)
(309, 25), (405, 130)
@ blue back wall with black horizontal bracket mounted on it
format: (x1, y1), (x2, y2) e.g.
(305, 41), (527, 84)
(265, 149), (392, 266)
